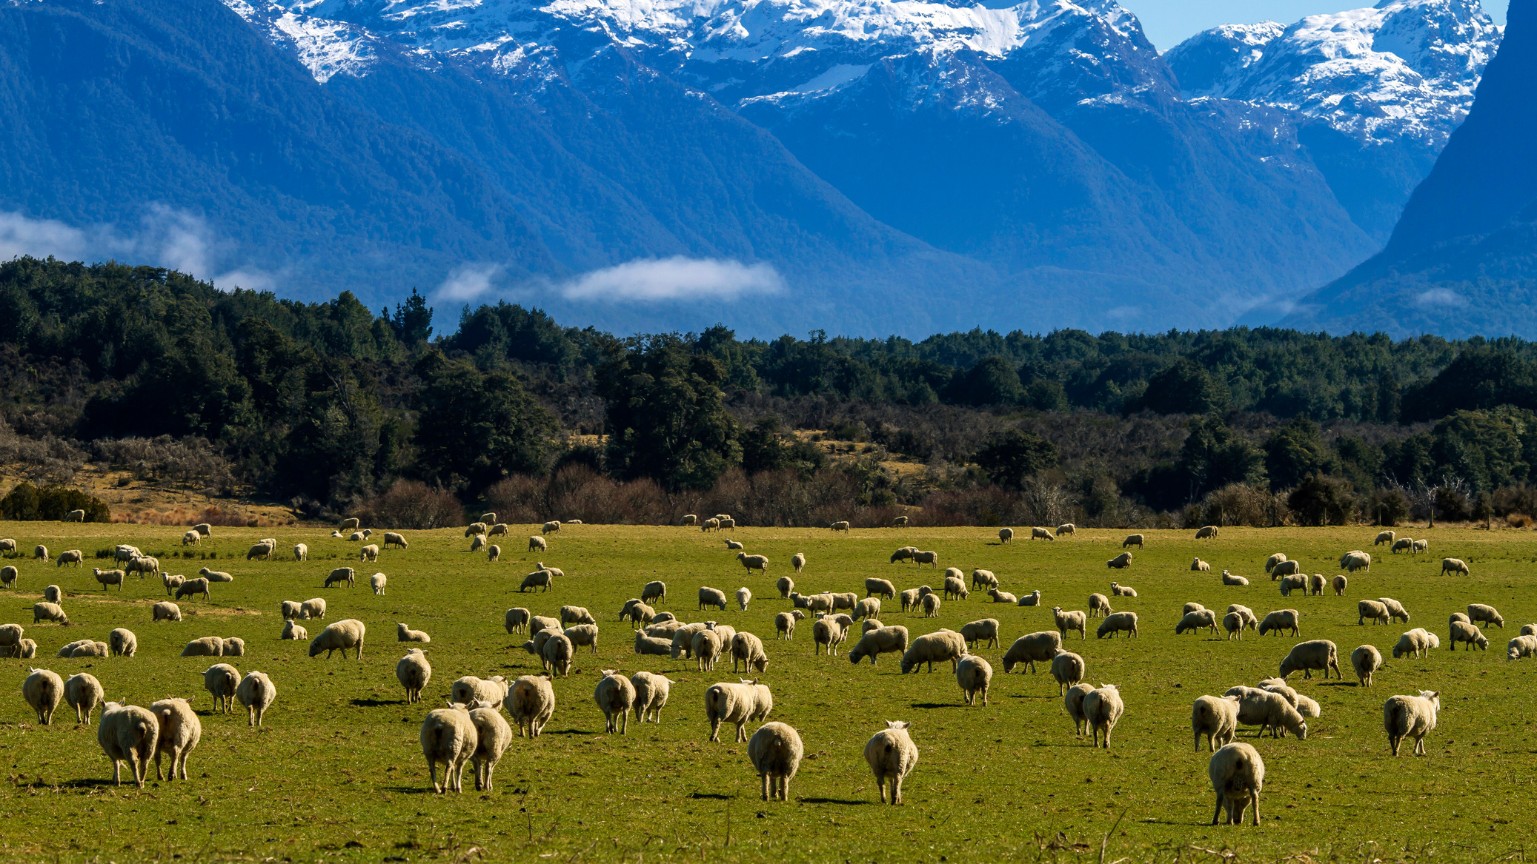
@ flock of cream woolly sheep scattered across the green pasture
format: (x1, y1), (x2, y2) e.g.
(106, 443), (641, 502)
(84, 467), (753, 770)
(0, 513), (1512, 824)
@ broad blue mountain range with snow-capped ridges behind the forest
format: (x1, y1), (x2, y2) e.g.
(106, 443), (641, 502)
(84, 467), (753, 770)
(0, 0), (1499, 335)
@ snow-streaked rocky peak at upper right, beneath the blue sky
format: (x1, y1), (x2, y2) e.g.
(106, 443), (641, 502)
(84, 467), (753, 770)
(1165, 0), (1503, 148)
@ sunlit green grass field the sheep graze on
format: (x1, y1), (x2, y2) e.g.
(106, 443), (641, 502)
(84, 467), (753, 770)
(0, 523), (1537, 861)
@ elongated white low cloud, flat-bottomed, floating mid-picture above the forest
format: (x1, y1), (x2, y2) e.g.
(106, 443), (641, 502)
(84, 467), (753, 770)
(556, 255), (785, 303)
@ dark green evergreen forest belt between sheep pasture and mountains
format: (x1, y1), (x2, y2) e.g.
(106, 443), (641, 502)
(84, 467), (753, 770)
(0, 258), (1537, 527)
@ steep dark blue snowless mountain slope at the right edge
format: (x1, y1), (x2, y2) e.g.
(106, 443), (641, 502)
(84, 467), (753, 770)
(1282, 0), (1537, 338)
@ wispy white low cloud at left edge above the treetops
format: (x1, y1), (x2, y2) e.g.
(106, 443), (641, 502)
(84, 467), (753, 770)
(0, 204), (277, 291)
